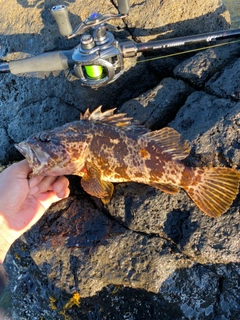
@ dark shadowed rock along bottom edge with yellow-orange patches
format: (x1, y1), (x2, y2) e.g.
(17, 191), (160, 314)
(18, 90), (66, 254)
(4, 245), (240, 320)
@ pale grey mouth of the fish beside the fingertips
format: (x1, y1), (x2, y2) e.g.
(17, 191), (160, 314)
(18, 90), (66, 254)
(15, 141), (49, 176)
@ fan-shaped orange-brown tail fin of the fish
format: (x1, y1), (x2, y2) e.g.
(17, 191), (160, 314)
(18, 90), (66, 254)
(183, 167), (240, 218)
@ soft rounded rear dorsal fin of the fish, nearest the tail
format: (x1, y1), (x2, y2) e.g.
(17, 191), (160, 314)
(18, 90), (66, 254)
(145, 127), (190, 160)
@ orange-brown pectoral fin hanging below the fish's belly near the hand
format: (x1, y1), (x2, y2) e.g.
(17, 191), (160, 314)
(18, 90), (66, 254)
(81, 163), (114, 204)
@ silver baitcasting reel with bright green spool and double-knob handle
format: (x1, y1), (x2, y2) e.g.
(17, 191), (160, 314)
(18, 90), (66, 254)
(51, 0), (129, 87)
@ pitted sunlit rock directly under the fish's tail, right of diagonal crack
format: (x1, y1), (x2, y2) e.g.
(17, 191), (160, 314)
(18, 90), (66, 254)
(108, 180), (240, 264)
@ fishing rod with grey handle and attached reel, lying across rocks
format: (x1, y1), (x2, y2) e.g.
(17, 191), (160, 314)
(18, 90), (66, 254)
(0, 0), (240, 88)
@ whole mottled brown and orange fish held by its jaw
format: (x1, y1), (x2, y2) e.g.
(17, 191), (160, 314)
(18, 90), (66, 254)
(15, 106), (240, 217)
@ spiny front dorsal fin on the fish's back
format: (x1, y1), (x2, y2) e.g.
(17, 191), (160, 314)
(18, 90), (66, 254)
(80, 106), (148, 134)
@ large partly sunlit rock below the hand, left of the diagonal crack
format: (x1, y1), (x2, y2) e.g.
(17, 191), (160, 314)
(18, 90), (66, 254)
(27, 199), (192, 297)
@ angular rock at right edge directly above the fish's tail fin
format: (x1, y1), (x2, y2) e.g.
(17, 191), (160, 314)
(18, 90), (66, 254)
(169, 91), (240, 167)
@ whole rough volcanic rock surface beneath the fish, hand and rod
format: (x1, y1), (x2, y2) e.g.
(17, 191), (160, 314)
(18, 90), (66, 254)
(0, 0), (240, 320)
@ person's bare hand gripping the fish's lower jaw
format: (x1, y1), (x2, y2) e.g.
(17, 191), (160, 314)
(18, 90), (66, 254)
(0, 160), (69, 262)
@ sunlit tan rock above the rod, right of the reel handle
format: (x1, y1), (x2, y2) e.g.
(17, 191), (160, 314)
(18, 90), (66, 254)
(122, 0), (230, 42)
